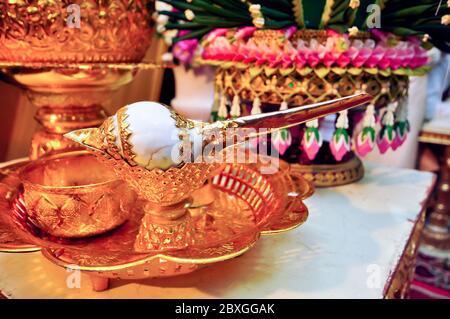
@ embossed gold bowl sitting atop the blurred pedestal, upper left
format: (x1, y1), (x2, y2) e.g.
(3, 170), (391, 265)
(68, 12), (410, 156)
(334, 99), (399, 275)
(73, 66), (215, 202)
(0, 0), (154, 63)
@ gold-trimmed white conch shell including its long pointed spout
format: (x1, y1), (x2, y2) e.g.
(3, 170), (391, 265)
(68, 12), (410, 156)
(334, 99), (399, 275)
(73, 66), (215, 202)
(65, 93), (372, 170)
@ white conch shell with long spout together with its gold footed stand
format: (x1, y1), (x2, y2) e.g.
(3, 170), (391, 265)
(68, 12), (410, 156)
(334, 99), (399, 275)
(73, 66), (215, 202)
(65, 94), (371, 252)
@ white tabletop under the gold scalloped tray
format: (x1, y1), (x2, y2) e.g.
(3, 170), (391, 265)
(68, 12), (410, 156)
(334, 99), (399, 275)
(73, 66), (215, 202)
(0, 165), (434, 298)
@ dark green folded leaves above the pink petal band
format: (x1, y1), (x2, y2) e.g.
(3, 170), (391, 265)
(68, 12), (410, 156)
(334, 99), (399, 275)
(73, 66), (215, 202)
(159, 0), (450, 52)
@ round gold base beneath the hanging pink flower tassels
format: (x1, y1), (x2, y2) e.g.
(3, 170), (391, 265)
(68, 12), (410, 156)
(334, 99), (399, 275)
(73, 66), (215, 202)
(291, 156), (364, 187)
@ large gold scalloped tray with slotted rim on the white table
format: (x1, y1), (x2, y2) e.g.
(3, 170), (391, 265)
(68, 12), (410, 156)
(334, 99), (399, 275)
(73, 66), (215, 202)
(0, 159), (314, 279)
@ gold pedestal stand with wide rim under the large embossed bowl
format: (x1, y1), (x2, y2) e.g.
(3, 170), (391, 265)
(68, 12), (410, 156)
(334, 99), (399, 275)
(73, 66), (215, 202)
(0, 61), (171, 159)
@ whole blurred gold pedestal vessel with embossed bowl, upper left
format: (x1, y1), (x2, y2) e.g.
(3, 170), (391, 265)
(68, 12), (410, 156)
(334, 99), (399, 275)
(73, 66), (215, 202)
(0, 0), (154, 159)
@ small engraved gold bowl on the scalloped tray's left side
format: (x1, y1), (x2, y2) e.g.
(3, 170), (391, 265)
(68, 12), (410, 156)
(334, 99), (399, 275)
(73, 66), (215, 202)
(19, 151), (136, 238)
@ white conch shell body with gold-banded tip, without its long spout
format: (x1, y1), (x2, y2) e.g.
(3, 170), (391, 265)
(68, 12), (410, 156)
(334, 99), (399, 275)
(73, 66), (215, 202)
(65, 102), (202, 170)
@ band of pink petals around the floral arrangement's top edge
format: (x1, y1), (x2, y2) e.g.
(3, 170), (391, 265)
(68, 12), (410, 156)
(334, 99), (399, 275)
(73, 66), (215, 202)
(203, 27), (428, 70)
